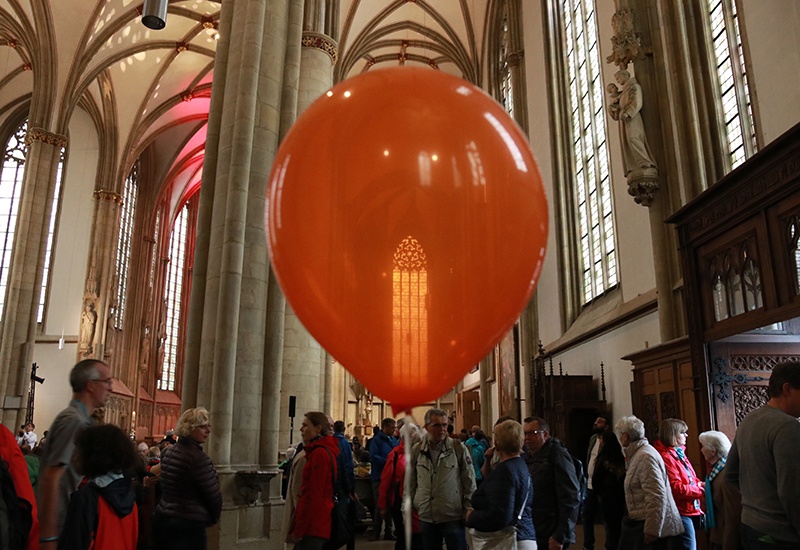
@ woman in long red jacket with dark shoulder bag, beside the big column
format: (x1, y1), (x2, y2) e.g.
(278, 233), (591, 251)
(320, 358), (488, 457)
(288, 412), (339, 550)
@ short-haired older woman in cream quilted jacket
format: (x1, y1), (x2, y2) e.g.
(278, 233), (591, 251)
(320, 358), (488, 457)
(614, 416), (683, 550)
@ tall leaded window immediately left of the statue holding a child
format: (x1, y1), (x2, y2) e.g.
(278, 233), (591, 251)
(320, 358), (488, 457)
(562, 0), (618, 304)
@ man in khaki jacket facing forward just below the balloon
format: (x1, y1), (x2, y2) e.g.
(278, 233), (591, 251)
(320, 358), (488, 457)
(409, 409), (475, 550)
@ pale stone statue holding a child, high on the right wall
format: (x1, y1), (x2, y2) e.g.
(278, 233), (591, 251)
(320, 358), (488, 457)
(606, 69), (657, 178)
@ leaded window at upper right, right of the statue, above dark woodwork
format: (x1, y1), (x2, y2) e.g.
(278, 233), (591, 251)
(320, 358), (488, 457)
(708, 0), (757, 169)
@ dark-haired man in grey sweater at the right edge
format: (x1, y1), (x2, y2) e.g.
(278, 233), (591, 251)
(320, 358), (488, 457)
(725, 361), (800, 550)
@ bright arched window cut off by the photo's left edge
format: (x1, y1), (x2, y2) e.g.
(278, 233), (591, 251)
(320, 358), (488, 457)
(0, 120), (28, 315)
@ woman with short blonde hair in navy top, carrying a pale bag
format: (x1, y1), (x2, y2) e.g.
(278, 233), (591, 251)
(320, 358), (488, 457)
(467, 420), (536, 550)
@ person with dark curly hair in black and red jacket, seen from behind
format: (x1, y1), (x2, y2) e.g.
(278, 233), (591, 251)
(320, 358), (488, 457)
(58, 424), (139, 550)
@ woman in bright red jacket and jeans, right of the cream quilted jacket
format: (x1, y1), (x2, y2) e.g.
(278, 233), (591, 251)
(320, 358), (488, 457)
(654, 418), (705, 550)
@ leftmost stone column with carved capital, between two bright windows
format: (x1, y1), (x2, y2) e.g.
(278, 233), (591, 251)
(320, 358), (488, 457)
(0, 127), (67, 433)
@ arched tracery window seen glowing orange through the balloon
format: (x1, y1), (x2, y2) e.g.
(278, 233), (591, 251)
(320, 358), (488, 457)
(392, 236), (428, 387)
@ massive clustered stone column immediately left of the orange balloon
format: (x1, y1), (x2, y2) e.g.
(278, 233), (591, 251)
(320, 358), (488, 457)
(183, 0), (299, 549)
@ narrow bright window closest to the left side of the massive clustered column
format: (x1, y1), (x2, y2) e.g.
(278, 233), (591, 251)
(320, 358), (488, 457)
(158, 203), (189, 391)
